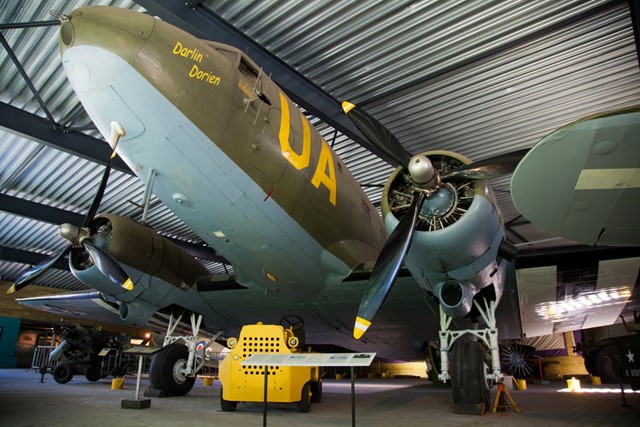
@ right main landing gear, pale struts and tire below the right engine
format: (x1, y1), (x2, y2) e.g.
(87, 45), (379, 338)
(438, 299), (502, 414)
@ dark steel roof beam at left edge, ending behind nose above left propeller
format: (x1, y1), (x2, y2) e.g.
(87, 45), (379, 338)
(0, 102), (133, 175)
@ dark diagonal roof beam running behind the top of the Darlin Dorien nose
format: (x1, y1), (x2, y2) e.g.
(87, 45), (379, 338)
(135, 0), (395, 164)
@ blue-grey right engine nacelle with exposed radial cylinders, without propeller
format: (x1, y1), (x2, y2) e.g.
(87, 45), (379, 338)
(382, 151), (504, 317)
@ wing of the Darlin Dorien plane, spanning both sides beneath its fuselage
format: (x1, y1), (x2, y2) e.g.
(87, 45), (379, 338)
(17, 247), (640, 360)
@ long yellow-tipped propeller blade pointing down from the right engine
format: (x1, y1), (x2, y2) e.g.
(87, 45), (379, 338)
(353, 192), (425, 339)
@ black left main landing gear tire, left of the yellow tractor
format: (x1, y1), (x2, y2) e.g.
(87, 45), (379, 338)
(149, 343), (196, 396)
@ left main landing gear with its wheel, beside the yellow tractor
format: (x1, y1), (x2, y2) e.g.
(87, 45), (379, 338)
(145, 313), (222, 397)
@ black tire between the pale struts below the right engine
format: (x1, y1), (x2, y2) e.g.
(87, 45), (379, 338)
(451, 341), (490, 411)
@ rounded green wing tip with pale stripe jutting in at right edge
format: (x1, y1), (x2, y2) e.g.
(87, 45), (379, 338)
(511, 108), (640, 246)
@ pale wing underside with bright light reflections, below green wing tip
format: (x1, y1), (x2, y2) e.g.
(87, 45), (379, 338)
(516, 247), (640, 337)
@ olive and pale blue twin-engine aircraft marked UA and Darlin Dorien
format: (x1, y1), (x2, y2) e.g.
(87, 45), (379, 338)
(13, 7), (640, 407)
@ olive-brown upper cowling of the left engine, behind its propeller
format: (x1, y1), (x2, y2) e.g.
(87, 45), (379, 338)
(70, 214), (210, 290)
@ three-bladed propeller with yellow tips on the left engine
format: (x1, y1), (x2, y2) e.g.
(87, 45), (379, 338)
(7, 122), (133, 295)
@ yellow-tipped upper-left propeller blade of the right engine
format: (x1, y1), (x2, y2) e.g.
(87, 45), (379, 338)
(342, 101), (411, 167)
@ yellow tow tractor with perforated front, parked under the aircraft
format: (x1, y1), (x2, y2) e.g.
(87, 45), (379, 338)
(218, 316), (322, 412)
